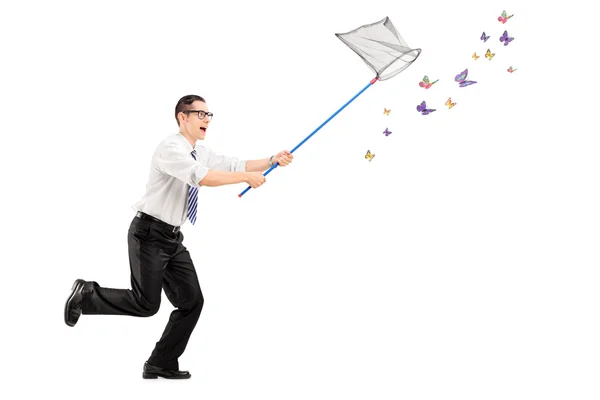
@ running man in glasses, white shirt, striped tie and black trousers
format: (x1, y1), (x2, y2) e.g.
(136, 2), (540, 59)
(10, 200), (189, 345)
(64, 95), (293, 379)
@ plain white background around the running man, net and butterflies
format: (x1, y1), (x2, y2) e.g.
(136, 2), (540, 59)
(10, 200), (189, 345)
(0, 0), (600, 400)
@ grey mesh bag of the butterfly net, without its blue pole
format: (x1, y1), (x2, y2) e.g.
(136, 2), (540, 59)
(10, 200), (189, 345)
(335, 17), (421, 81)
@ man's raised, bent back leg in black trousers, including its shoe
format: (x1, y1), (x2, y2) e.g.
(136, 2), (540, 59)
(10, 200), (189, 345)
(65, 218), (168, 326)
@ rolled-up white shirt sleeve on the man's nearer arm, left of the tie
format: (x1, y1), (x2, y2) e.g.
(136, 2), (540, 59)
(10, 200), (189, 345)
(154, 144), (209, 187)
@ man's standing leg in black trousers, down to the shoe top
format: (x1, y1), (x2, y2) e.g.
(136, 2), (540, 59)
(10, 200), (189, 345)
(148, 239), (204, 370)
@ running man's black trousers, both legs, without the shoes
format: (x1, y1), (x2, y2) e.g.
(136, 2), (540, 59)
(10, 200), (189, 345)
(81, 217), (204, 369)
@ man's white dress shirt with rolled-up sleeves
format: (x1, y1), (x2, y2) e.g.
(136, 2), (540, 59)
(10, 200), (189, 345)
(131, 132), (246, 226)
